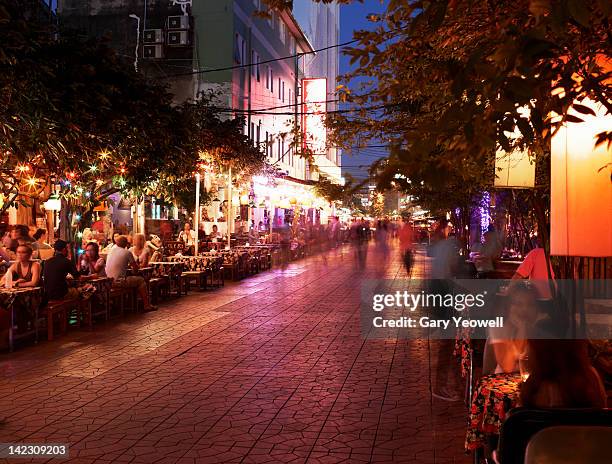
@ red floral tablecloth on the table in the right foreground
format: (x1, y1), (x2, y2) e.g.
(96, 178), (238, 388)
(465, 373), (521, 451)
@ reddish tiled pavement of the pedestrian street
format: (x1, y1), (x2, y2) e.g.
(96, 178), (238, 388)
(0, 246), (470, 464)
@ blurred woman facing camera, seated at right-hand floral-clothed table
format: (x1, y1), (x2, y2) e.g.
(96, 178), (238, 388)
(483, 284), (538, 374)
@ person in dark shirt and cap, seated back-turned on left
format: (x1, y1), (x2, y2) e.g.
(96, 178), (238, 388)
(43, 240), (79, 300)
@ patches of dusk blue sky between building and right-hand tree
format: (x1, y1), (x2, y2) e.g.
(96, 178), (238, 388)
(340, 0), (386, 184)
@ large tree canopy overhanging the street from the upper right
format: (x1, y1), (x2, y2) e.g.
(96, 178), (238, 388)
(266, 0), (612, 214)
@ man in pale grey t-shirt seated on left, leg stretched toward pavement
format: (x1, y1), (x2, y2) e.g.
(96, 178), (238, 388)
(106, 235), (157, 311)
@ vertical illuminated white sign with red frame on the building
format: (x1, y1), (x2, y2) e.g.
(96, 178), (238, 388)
(302, 78), (327, 155)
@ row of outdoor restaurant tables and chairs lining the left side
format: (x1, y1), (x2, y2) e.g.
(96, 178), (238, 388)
(0, 242), (334, 351)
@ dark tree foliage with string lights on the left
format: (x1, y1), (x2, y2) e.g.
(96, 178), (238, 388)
(0, 0), (265, 214)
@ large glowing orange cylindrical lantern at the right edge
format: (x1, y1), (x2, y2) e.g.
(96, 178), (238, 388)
(550, 99), (612, 257)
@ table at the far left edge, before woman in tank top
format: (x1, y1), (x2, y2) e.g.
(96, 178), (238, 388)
(0, 287), (42, 351)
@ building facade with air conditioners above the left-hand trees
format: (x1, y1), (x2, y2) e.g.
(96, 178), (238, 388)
(57, 0), (340, 228)
